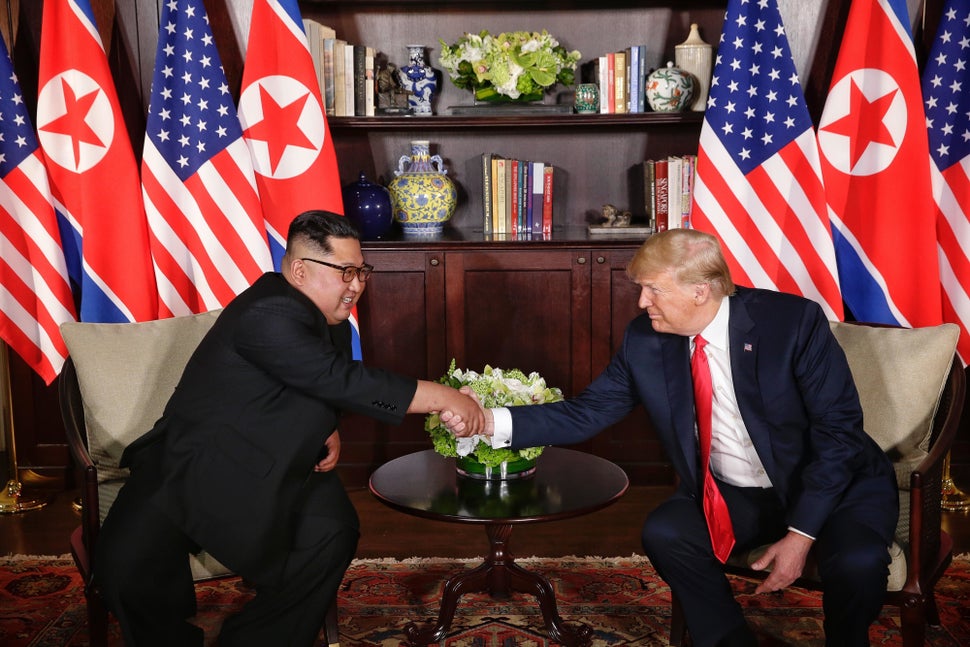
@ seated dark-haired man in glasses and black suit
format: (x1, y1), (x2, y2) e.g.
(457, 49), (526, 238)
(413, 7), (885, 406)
(94, 211), (484, 647)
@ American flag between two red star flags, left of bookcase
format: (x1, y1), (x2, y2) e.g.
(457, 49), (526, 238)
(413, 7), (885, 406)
(142, 0), (272, 316)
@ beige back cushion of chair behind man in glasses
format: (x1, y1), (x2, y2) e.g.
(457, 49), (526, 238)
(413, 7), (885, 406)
(61, 310), (221, 521)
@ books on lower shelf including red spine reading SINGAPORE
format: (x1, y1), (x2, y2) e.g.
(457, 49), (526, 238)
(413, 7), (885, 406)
(642, 155), (697, 231)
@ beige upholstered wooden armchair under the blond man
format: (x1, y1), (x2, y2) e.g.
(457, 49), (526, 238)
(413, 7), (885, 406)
(670, 322), (966, 647)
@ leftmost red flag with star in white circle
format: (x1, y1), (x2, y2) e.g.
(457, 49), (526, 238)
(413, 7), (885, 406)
(37, 0), (158, 323)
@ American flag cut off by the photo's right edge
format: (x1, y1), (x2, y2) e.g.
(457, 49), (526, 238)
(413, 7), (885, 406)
(923, 0), (970, 364)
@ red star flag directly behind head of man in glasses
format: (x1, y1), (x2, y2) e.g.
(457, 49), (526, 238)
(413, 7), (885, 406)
(239, 0), (361, 359)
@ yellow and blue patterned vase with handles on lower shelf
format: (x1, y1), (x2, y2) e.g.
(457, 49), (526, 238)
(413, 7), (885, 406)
(387, 140), (458, 236)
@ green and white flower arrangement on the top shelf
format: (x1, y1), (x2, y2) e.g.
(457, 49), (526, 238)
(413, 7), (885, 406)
(439, 30), (582, 100)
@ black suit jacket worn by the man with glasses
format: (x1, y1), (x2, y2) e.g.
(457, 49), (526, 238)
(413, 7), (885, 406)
(123, 273), (417, 583)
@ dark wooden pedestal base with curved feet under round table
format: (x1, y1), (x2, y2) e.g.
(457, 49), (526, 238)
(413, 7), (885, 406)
(404, 524), (593, 647)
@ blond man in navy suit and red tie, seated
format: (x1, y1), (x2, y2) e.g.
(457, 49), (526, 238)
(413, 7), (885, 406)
(443, 229), (898, 646)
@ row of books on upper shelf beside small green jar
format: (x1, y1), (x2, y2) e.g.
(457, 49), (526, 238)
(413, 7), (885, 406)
(582, 45), (649, 114)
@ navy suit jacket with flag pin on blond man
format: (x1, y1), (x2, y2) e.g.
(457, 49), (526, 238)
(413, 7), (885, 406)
(511, 288), (898, 544)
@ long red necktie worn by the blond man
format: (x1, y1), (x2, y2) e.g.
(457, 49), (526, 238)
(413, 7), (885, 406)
(690, 335), (734, 563)
